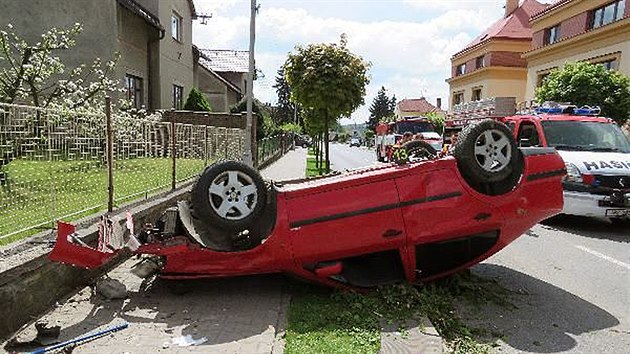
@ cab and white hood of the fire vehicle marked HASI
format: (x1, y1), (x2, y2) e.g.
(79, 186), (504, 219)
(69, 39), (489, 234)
(502, 112), (630, 222)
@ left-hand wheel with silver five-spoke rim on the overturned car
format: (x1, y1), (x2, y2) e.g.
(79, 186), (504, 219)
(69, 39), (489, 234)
(190, 161), (266, 232)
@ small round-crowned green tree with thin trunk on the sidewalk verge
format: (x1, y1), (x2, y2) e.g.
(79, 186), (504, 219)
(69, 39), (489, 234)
(284, 34), (370, 171)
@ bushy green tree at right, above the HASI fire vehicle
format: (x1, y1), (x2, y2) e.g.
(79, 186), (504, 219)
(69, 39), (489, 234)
(536, 62), (630, 125)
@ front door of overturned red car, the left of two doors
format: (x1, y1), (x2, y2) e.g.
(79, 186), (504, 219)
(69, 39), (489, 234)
(287, 179), (406, 286)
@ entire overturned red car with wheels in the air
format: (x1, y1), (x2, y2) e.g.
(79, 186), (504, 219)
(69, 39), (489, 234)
(50, 120), (565, 288)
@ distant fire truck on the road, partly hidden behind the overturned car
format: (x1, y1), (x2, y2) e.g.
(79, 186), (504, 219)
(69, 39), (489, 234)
(374, 117), (442, 162)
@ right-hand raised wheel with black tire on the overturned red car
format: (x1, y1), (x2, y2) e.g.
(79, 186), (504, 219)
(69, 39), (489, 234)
(453, 119), (519, 183)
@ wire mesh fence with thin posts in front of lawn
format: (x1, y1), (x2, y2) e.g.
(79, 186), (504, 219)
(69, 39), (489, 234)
(0, 104), (245, 244)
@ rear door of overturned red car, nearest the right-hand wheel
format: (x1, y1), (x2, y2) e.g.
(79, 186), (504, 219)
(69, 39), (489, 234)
(396, 165), (503, 280)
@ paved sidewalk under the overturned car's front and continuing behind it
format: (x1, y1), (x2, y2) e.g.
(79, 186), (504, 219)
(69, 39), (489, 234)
(4, 148), (306, 354)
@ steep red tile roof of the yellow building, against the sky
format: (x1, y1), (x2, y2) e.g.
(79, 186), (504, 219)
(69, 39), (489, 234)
(454, 0), (548, 56)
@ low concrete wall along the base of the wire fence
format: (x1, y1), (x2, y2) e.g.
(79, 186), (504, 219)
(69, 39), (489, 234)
(0, 186), (190, 338)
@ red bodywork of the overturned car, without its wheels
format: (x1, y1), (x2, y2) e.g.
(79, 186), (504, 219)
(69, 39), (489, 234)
(50, 149), (564, 286)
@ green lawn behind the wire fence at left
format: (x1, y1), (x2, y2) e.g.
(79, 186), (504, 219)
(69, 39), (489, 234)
(0, 158), (204, 245)
